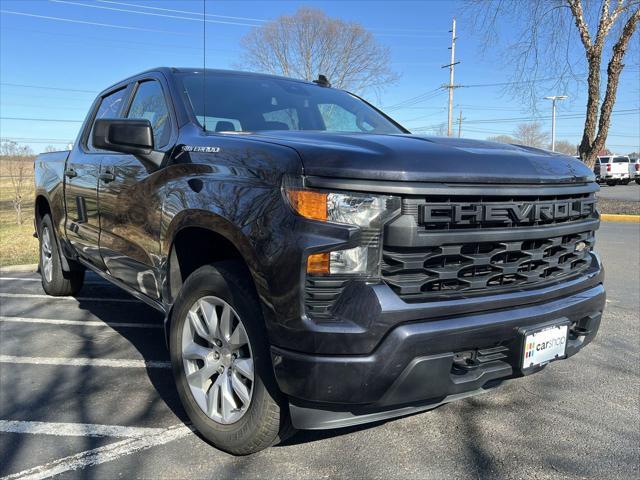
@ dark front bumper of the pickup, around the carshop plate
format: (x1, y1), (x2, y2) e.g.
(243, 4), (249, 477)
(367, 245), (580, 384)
(272, 275), (605, 429)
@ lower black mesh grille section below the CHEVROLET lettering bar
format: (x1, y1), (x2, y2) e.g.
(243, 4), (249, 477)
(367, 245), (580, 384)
(382, 232), (593, 300)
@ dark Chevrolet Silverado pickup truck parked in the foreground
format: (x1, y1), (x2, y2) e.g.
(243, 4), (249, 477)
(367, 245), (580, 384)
(35, 68), (605, 454)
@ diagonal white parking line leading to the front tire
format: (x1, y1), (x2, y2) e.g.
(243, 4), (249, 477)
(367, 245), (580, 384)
(3, 425), (191, 480)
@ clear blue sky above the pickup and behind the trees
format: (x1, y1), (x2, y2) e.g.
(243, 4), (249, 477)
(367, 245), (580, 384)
(0, 0), (640, 153)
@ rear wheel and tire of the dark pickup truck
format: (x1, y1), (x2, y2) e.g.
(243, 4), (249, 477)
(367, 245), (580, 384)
(38, 214), (84, 297)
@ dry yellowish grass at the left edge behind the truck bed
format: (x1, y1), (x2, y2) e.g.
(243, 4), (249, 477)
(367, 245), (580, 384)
(0, 158), (38, 266)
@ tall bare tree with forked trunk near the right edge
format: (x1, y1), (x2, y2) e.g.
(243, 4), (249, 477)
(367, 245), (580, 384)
(467, 0), (640, 167)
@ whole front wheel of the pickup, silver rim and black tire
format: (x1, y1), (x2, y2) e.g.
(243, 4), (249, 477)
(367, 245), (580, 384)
(170, 262), (291, 455)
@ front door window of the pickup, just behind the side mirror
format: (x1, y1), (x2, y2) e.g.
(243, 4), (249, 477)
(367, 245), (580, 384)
(127, 80), (171, 148)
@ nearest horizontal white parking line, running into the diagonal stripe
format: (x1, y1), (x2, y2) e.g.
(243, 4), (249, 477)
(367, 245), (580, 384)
(0, 420), (164, 438)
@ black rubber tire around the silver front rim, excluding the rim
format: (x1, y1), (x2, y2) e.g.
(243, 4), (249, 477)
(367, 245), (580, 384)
(169, 261), (293, 455)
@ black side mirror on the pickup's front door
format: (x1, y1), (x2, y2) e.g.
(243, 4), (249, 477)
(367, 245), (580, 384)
(92, 118), (161, 167)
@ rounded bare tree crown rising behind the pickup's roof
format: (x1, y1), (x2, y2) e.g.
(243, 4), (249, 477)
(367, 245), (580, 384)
(240, 7), (397, 93)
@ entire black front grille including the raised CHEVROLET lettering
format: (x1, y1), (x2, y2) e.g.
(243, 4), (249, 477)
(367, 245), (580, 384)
(381, 187), (598, 302)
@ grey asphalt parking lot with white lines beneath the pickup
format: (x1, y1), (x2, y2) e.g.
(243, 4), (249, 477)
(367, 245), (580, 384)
(0, 222), (640, 479)
